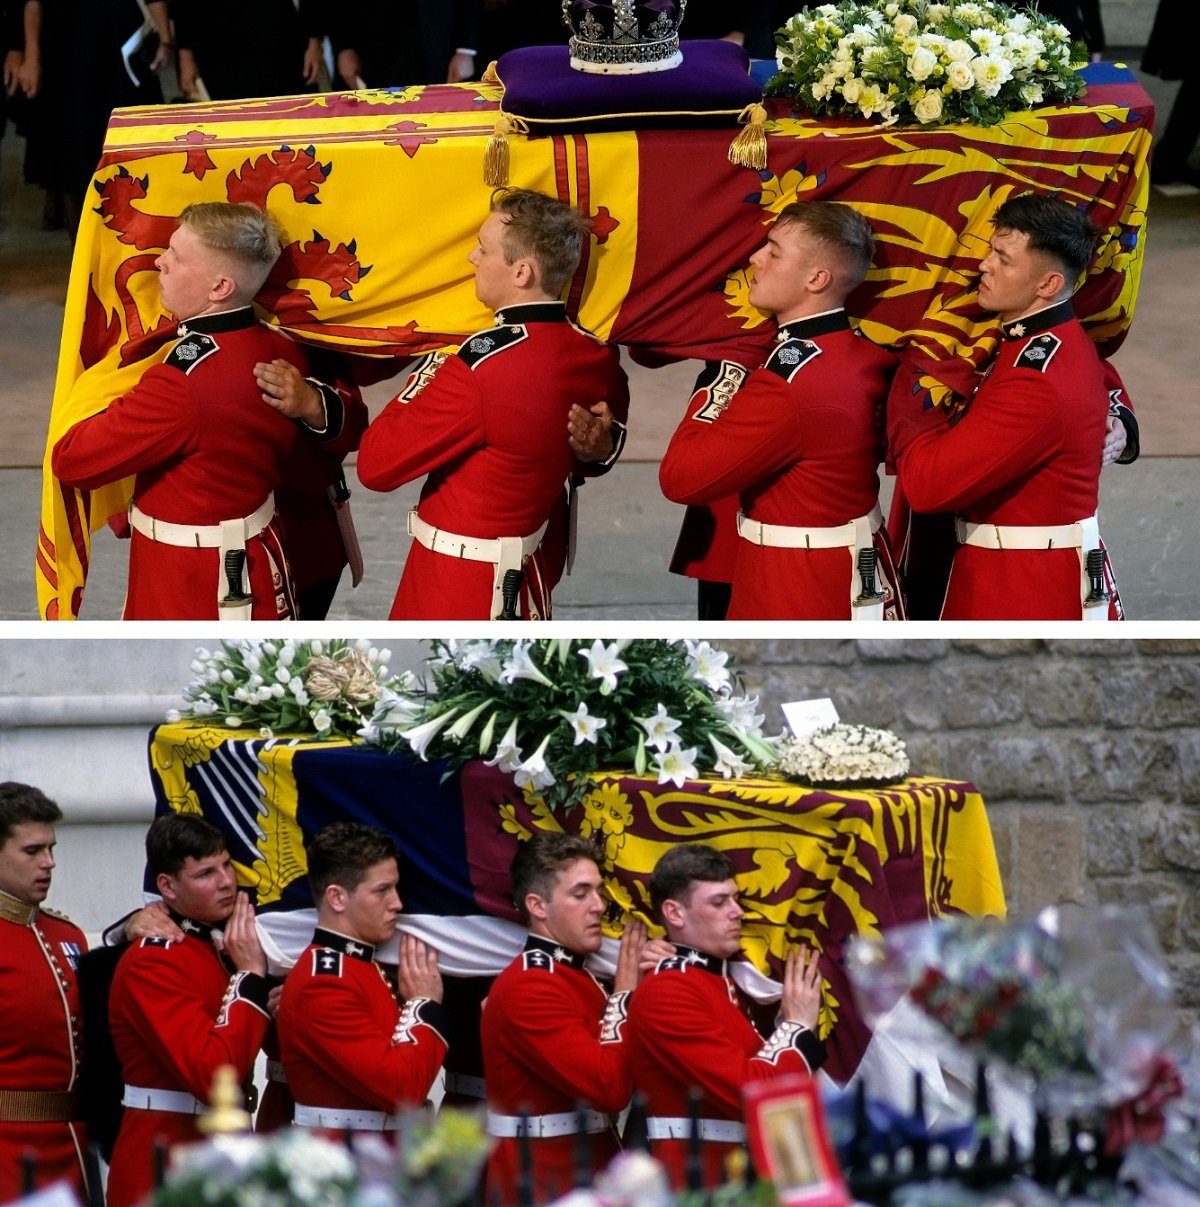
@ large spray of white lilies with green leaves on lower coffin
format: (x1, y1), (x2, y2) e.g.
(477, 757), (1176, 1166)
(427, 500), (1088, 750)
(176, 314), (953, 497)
(363, 639), (775, 810)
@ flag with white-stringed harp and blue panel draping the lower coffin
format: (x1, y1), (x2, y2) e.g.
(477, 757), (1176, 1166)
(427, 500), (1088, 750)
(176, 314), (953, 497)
(147, 722), (1004, 1080)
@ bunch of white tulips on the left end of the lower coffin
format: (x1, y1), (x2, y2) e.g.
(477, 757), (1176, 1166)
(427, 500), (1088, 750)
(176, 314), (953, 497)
(167, 640), (414, 737)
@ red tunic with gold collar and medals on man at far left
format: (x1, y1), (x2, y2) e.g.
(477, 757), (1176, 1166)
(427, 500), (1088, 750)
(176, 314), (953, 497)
(0, 893), (87, 1203)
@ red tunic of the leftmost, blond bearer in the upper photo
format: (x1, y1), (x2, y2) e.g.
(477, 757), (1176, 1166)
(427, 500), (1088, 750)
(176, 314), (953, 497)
(51, 307), (350, 620)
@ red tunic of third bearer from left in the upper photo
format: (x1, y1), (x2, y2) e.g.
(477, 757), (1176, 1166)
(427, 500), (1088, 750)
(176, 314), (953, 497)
(659, 310), (895, 620)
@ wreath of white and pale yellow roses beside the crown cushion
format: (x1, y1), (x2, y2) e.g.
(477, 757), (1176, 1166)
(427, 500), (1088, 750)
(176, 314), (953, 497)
(767, 0), (1087, 126)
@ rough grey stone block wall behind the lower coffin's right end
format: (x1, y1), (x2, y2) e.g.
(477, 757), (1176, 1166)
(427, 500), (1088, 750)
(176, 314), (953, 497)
(721, 640), (1200, 1024)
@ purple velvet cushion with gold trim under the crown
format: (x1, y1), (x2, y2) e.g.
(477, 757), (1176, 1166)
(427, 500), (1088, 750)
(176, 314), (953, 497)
(496, 41), (762, 133)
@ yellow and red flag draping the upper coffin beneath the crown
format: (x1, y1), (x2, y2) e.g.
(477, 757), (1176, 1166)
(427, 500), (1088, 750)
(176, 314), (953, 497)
(36, 69), (1139, 619)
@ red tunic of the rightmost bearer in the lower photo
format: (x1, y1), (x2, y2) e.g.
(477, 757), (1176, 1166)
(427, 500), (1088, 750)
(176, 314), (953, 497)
(628, 944), (825, 1188)
